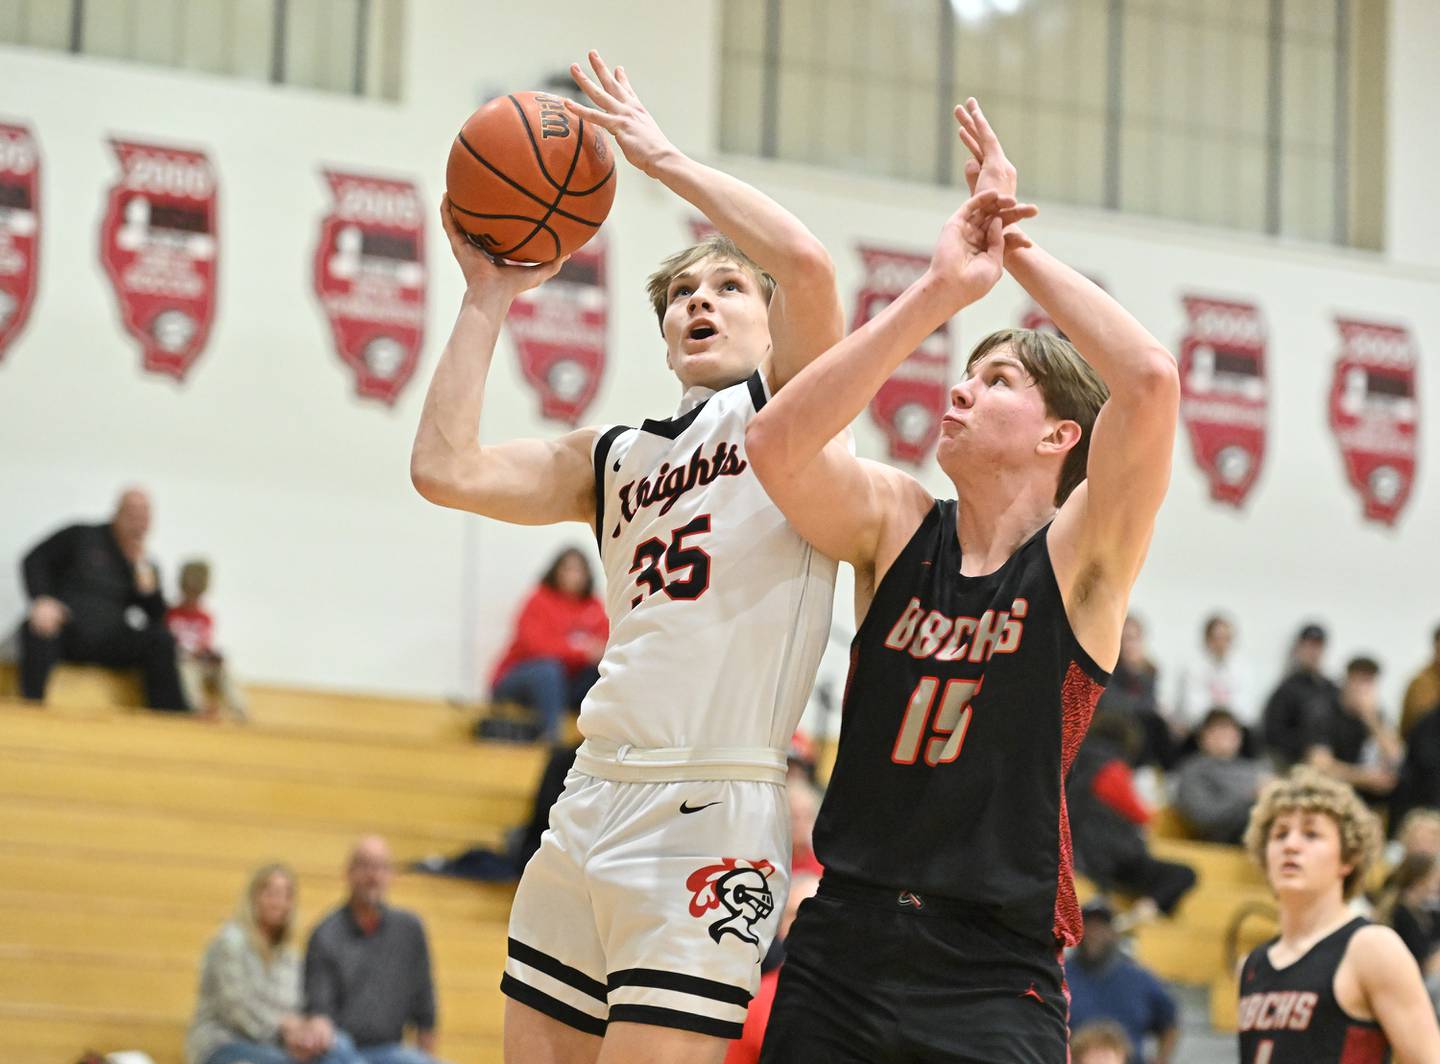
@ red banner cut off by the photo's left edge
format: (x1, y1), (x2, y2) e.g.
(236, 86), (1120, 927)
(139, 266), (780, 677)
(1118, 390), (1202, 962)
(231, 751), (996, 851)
(0, 122), (40, 359)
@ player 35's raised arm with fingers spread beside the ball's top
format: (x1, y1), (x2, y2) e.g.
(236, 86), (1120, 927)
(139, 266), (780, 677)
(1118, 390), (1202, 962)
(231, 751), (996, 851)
(566, 52), (845, 390)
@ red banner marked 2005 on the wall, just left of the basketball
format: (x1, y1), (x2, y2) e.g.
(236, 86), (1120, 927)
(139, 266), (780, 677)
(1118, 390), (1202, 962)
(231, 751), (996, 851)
(314, 170), (426, 403)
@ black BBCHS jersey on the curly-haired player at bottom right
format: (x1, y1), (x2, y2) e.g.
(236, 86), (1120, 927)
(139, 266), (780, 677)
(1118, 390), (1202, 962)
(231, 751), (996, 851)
(1238, 916), (1390, 1064)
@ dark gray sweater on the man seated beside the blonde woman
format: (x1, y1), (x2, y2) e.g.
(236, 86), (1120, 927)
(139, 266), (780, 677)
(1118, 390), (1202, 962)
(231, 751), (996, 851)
(305, 907), (435, 1048)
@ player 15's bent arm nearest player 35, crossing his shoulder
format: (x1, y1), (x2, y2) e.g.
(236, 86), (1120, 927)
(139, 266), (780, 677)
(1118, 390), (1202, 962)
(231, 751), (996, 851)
(744, 191), (1034, 569)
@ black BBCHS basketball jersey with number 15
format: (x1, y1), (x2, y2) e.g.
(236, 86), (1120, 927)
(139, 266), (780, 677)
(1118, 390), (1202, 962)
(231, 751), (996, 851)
(815, 500), (1109, 946)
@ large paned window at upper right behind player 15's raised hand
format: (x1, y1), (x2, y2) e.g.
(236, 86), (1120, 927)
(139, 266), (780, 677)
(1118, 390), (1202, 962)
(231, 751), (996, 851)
(719, 0), (1388, 249)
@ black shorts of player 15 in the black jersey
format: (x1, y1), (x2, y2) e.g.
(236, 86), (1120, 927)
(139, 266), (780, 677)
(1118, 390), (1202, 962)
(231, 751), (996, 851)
(760, 877), (1068, 1064)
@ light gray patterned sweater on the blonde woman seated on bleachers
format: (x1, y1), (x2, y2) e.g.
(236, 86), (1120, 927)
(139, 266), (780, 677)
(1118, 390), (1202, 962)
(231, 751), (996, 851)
(184, 920), (300, 1064)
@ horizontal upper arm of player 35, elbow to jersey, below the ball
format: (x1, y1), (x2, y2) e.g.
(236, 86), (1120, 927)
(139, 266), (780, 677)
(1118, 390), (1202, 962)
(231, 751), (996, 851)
(410, 428), (596, 524)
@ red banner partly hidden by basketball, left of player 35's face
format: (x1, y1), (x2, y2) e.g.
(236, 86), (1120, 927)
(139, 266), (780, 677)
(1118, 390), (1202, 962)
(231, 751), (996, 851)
(505, 233), (608, 425)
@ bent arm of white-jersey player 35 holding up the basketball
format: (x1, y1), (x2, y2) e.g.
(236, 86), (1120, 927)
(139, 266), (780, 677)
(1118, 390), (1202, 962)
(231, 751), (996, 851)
(410, 202), (595, 524)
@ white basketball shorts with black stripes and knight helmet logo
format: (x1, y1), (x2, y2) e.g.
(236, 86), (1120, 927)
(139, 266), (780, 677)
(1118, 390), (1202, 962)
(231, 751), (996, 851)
(500, 769), (791, 1038)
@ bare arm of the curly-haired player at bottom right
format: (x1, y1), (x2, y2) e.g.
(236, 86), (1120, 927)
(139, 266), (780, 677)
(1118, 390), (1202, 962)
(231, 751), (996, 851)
(1345, 926), (1440, 1064)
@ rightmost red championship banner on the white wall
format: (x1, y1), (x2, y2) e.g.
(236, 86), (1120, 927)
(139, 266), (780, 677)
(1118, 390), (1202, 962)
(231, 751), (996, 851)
(1331, 318), (1420, 524)
